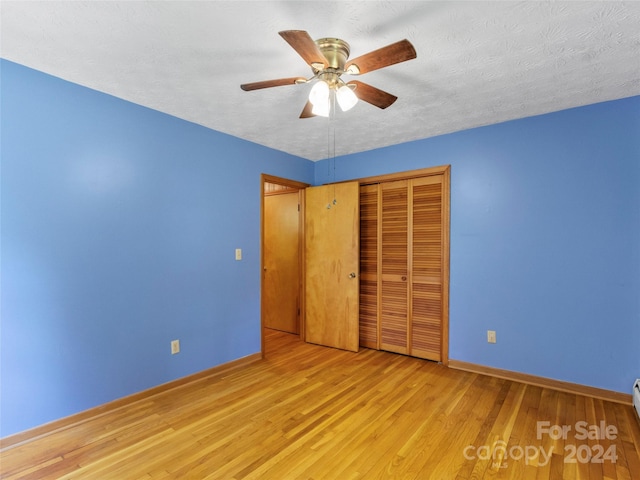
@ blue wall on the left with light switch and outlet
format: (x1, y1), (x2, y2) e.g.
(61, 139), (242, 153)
(0, 61), (313, 436)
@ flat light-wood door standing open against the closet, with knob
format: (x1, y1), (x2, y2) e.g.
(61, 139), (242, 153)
(305, 182), (360, 352)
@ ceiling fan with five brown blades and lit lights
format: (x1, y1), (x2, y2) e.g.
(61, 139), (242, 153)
(240, 30), (416, 118)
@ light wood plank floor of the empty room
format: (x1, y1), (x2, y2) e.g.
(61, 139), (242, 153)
(0, 332), (640, 480)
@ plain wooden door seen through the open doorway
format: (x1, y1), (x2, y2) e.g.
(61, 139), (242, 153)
(263, 192), (300, 334)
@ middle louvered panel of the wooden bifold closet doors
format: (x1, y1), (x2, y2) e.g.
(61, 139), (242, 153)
(380, 180), (409, 354)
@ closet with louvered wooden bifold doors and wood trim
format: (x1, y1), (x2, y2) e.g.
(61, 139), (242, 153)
(360, 166), (450, 363)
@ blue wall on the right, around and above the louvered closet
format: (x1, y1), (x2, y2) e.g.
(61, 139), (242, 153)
(315, 97), (640, 394)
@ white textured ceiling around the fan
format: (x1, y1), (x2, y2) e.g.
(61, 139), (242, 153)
(0, 1), (640, 160)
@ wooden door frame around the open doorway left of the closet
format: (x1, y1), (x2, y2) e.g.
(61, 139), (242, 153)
(260, 173), (311, 358)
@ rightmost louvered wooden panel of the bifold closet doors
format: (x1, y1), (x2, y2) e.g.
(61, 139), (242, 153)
(409, 175), (443, 362)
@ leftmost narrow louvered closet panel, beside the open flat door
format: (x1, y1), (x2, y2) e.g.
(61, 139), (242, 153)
(360, 185), (379, 349)
